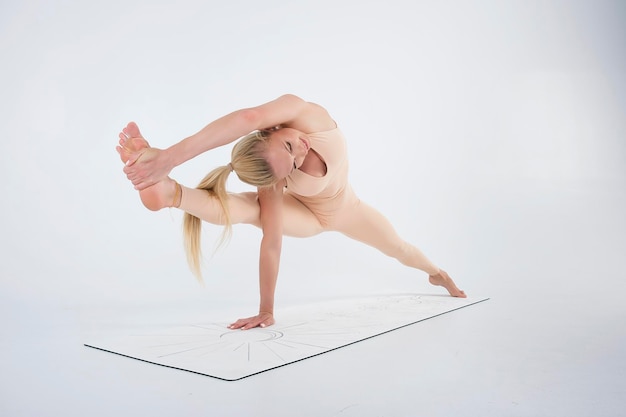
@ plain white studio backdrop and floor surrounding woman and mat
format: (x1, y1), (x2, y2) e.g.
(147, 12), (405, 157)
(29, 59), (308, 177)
(0, 0), (626, 416)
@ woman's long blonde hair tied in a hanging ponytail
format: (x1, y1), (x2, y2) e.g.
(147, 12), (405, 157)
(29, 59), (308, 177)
(183, 130), (278, 280)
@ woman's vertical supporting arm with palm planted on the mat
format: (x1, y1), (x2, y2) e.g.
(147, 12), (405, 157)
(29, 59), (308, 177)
(228, 184), (283, 330)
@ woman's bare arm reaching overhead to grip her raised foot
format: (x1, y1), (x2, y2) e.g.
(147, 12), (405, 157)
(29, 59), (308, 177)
(124, 94), (309, 190)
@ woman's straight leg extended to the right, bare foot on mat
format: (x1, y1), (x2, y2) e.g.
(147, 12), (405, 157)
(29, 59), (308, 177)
(333, 202), (466, 297)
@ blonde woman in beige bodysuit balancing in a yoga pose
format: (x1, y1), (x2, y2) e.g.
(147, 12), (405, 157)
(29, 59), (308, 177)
(116, 95), (466, 330)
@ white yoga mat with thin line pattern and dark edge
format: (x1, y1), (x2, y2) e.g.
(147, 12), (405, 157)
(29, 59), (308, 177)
(85, 294), (488, 381)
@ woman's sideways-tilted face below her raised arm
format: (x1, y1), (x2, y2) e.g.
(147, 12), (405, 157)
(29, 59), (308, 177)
(266, 128), (311, 179)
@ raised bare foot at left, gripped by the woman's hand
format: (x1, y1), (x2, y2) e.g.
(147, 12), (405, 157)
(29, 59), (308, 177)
(115, 122), (178, 211)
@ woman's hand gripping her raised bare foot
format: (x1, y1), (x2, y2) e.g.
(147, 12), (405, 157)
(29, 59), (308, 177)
(124, 148), (174, 190)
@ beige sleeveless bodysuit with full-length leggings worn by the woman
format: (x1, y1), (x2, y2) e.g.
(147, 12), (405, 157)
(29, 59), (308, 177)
(181, 128), (439, 275)
